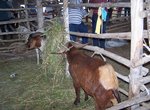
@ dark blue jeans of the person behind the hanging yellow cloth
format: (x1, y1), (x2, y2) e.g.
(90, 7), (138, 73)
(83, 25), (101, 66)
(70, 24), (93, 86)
(92, 14), (106, 48)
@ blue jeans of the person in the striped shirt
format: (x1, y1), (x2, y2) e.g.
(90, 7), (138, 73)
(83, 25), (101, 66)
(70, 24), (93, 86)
(69, 22), (88, 44)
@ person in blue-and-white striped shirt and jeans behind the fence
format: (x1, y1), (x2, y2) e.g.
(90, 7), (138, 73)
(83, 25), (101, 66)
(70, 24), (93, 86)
(69, 0), (88, 44)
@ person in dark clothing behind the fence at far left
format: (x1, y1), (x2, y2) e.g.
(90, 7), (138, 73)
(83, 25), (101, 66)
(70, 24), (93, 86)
(0, 0), (14, 39)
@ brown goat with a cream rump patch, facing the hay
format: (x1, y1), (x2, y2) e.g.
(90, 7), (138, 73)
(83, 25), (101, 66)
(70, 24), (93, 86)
(61, 42), (120, 110)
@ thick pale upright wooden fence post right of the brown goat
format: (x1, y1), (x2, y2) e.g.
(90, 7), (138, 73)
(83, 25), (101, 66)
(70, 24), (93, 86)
(129, 0), (143, 110)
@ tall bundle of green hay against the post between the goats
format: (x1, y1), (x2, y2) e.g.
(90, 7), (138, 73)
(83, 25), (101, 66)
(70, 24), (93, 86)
(42, 18), (65, 85)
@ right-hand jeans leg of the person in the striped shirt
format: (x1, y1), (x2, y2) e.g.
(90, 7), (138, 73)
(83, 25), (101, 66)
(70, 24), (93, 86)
(78, 22), (88, 44)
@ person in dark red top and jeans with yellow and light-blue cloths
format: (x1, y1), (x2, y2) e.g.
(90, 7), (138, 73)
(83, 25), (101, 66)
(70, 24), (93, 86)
(89, 0), (107, 48)
